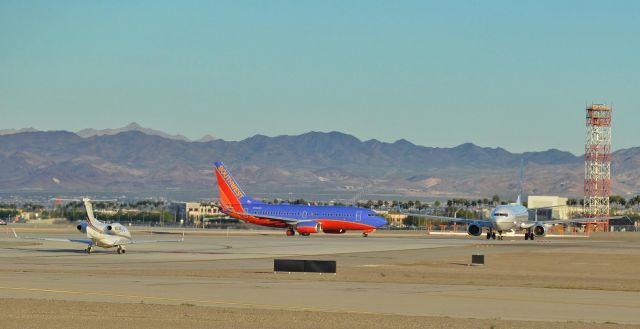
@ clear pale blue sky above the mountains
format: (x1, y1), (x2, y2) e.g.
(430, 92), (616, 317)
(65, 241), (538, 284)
(0, 0), (640, 154)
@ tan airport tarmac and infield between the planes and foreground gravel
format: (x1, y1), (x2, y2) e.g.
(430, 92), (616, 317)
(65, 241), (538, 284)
(0, 226), (640, 328)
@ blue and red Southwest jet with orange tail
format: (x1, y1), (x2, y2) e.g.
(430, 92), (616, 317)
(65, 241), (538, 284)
(215, 161), (387, 237)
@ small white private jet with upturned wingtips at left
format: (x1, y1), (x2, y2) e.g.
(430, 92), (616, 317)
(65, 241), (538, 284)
(13, 198), (184, 254)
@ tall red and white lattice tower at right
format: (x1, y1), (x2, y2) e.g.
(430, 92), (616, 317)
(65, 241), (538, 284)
(584, 104), (612, 223)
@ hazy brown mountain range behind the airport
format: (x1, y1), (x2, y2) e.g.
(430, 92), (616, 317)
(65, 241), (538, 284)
(0, 124), (640, 199)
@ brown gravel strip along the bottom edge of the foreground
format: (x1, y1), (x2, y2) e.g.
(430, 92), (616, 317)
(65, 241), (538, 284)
(0, 299), (638, 329)
